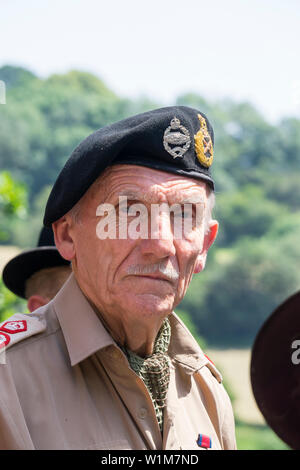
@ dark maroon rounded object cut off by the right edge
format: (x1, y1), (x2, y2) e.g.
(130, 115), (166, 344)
(251, 292), (300, 449)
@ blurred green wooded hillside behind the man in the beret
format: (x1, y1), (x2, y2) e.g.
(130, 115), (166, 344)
(0, 65), (300, 450)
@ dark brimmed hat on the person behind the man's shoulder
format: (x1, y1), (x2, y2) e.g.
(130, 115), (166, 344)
(2, 227), (70, 298)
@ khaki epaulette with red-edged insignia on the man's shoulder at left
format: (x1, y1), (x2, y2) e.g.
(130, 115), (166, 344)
(0, 313), (46, 352)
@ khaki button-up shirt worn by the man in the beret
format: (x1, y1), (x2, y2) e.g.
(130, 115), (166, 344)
(0, 274), (236, 450)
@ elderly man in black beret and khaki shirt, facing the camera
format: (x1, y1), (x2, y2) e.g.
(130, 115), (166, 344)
(0, 107), (236, 450)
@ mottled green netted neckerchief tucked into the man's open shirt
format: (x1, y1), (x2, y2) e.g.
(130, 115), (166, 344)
(125, 318), (171, 432)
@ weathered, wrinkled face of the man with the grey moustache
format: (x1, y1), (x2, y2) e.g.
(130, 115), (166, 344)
(59, 165), (217, 330)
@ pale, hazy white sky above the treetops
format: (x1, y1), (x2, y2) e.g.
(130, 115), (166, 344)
(0, 0), (300, 121)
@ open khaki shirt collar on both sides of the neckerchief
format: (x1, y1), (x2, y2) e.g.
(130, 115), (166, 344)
(53, 273), (222, 382)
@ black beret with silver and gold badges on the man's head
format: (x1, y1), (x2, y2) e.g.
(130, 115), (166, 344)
(44, 106), (214, 226)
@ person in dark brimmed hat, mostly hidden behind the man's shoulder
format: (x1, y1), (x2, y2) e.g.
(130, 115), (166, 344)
(2, 227), (72, 312)
